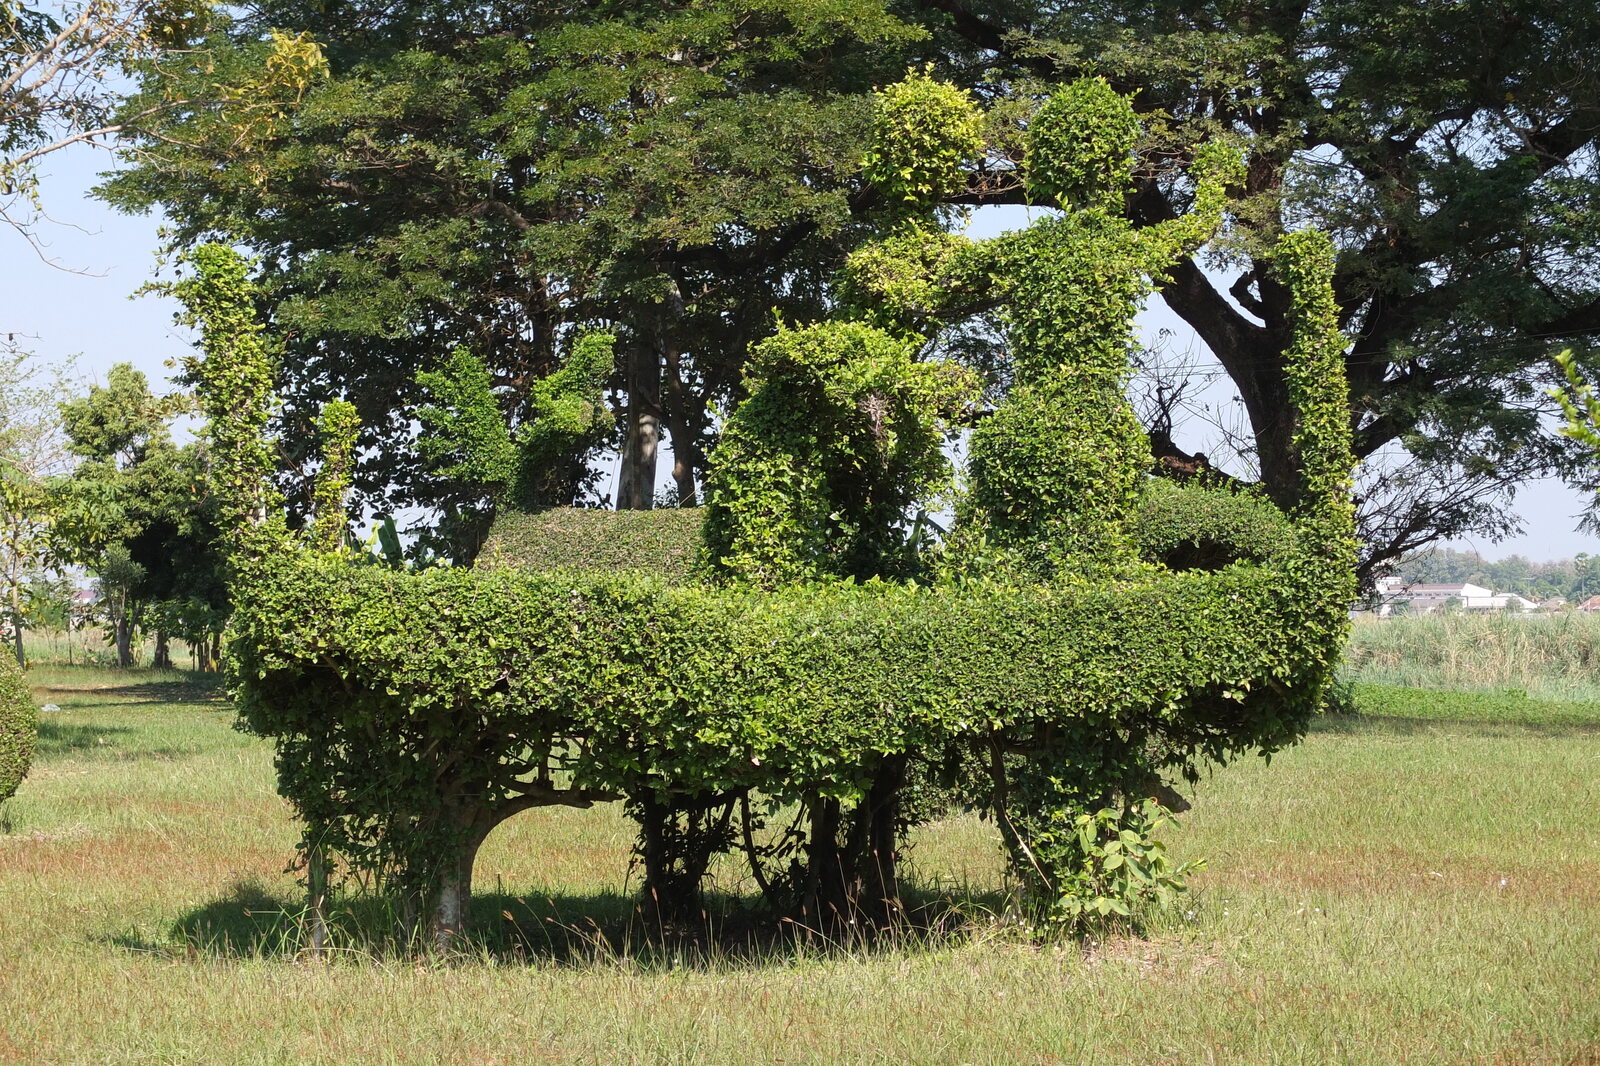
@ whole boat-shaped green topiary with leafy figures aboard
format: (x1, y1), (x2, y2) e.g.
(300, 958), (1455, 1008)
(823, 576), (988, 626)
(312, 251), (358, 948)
(197, 80), (1354, 943)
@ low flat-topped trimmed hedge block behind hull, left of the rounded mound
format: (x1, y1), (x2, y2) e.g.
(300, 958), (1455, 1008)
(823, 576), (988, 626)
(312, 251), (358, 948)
(477, 507), (706, 584)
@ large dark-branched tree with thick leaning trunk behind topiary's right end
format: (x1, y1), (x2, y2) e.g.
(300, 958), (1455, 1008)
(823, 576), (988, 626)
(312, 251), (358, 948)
(917, 0), (1600, 568)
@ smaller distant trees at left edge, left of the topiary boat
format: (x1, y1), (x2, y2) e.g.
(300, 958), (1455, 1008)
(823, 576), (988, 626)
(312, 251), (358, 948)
(0, 354), (227, 669)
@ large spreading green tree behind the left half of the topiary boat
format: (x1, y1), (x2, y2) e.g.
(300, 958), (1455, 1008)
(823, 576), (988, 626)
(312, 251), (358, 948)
(109, 0), (917, 549)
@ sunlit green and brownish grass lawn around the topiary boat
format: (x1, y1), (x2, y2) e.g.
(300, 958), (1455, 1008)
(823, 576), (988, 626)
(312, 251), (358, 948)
(0, 667), (1600, 1066)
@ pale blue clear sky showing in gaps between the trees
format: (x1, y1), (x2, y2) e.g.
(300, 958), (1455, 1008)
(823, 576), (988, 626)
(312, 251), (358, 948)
(12, 147), (1600, 560)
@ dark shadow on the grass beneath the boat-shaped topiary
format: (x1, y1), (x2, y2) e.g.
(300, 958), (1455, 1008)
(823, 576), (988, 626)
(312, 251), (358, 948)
(109, 880), (1003, 968)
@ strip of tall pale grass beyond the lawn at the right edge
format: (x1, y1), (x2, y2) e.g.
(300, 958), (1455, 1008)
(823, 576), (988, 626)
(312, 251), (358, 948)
(1346, 611), (1600, 699)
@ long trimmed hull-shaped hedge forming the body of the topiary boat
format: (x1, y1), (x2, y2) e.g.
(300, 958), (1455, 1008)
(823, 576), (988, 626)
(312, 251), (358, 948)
(232, 518), (1342, 888)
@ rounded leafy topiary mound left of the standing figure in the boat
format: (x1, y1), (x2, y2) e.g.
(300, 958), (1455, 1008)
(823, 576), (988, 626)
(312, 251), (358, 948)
(706, 322), (978, 587)
